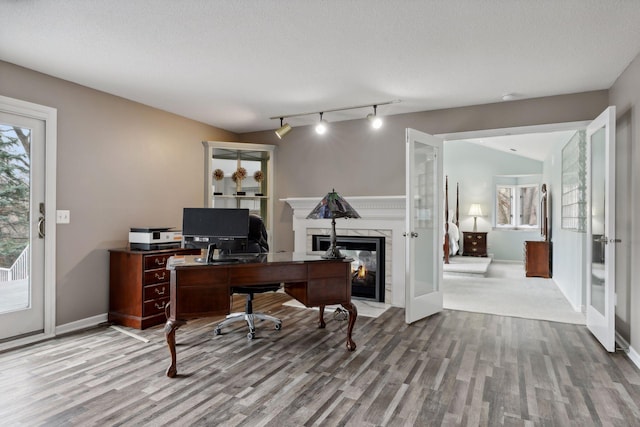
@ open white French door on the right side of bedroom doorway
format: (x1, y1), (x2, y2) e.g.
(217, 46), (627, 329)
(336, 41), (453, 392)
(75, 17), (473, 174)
(586, 107), (616, 351)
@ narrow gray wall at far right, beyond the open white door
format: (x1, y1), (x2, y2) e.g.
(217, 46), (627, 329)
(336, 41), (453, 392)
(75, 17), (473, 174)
(609, 52), (640, 354)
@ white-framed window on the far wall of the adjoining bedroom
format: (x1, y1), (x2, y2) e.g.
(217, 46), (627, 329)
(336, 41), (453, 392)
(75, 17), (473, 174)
(495, 184), (540, 228)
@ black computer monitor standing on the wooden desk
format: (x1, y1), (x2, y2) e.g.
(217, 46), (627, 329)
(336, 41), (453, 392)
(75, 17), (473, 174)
(182, 208), (249, 249)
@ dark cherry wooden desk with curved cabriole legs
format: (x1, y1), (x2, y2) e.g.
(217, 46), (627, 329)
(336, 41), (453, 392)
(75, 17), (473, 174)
(164, 253), (358, 378)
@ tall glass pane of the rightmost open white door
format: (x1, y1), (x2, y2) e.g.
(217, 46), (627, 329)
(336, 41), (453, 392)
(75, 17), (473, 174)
(590, 128), (606, 315)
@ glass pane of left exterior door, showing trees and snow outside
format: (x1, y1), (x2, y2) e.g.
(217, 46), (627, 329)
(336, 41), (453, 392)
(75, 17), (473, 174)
(0, 123), (31, 313)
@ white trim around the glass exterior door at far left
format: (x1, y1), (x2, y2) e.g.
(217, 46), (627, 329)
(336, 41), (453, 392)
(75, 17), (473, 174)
(0, 95), (58, 351)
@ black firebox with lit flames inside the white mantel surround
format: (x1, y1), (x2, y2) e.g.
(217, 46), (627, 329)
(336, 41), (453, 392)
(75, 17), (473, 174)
(312, 234), (385, 302)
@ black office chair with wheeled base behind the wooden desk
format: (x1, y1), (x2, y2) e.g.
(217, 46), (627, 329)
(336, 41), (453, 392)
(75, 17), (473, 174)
(213, 215), (282, 340)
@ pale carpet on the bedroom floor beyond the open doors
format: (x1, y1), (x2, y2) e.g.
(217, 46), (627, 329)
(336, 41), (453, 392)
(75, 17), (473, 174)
(442, 261), (585, 325)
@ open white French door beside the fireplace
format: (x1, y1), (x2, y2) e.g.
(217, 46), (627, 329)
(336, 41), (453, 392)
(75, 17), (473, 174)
(405, 129), (444, 323)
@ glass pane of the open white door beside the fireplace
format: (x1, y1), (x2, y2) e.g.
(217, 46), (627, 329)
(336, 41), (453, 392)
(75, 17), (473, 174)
(411, 144), (441, 297)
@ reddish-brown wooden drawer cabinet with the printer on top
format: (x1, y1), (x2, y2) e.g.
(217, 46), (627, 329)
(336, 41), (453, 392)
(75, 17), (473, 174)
(108, 248), (200, 329)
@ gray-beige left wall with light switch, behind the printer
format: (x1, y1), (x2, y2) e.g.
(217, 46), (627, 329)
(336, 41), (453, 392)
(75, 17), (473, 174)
(0, 61), (237, 325)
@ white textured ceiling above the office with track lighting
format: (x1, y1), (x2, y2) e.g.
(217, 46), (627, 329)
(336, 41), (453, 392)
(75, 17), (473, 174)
(0, 0), (640, 133)
